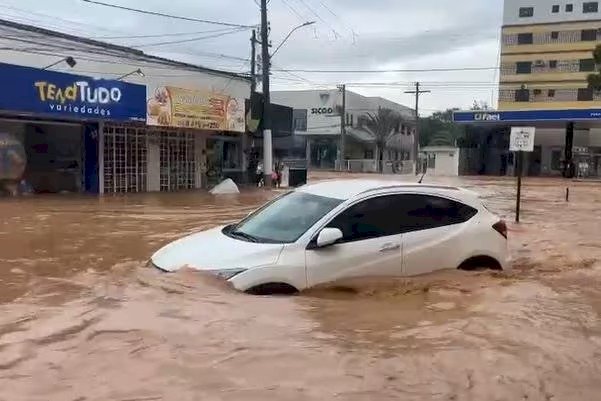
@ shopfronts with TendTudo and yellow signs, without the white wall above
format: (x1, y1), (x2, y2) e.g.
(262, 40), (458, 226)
(0, 59), (246, 194)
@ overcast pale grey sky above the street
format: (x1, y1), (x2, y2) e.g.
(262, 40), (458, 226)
(0, 0), (502, 114)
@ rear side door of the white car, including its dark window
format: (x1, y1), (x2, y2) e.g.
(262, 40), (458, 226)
(402, 194), (478, 275)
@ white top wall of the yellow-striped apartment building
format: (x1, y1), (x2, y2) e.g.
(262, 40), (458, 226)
(503, 0), (601, 25)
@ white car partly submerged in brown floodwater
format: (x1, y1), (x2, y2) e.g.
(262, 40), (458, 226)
(151, 180), (509, 294)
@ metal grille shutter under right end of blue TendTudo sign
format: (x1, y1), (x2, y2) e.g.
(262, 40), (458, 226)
(103, 124), (148, 193)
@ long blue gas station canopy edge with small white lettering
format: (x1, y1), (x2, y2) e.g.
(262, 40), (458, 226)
(453, 109), (601, 123)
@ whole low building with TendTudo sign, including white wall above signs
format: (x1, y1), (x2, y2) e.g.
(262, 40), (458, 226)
(0, 21), (250, 194)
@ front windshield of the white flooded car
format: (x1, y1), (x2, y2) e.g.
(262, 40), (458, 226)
(227, 191), (342, 243)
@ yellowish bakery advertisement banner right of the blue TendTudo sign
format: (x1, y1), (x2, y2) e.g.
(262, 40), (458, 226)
(146, 86), (246, 133)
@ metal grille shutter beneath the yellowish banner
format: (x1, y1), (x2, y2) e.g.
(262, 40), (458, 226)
(159, 131), (196, 191)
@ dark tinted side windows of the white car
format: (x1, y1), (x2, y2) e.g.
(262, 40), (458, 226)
(327, 194), (477, 242)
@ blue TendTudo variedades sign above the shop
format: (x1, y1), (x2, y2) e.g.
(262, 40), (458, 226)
(0, 63), (146, 122)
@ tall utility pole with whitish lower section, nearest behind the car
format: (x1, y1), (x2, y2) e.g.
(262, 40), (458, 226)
(261, 0), (273, 188)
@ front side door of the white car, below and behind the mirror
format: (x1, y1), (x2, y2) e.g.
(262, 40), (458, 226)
(305, 195), (402, 287)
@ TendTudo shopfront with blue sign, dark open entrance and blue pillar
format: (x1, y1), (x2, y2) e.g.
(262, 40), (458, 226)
(0, 63), (146, 193)
